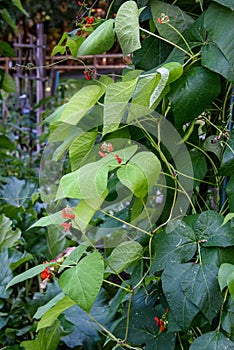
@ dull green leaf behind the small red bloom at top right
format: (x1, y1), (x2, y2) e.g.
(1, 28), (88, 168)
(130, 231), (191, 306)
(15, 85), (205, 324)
(150, 0), (194, 44)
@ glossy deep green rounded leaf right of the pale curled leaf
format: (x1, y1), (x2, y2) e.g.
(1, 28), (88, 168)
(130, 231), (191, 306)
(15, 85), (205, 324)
(168, 66), (220, 127)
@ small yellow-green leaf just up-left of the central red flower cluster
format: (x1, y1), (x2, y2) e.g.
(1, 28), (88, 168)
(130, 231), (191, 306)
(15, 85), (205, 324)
(69, 131), (97, 171)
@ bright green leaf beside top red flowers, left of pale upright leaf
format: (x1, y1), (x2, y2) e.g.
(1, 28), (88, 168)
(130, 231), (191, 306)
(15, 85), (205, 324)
(78, 19), (115, 56)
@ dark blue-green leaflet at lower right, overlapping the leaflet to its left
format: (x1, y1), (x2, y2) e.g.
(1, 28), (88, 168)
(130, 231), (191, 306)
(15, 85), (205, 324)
(181, 264), (223, 324)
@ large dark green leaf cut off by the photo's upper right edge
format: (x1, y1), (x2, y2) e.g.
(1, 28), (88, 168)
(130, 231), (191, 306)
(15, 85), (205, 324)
(202, 3), (234, 82)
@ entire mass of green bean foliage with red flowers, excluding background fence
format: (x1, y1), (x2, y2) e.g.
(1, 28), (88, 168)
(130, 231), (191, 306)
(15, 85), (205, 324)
(0, 0), (234, 350)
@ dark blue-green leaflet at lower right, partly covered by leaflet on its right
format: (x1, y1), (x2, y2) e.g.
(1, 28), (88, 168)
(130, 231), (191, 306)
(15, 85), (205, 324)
(162, 263), (199, 332)
